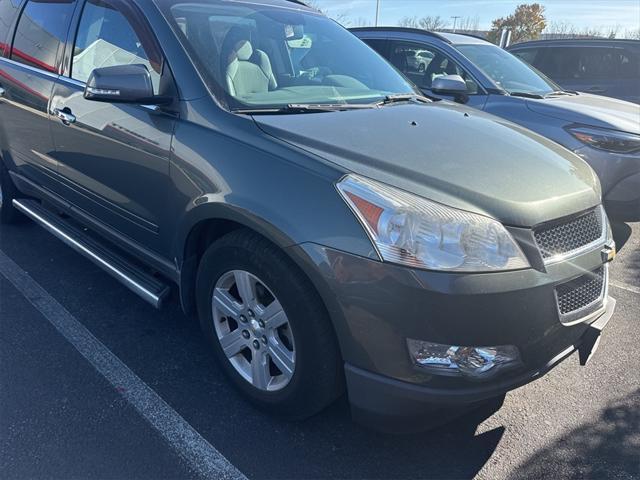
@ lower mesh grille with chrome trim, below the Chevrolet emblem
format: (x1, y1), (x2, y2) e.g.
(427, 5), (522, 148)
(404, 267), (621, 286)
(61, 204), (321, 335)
(556, 266), (608, 322)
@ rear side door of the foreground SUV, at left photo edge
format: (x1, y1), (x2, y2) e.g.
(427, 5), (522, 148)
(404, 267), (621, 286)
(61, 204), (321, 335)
(0, 0), (76, 189)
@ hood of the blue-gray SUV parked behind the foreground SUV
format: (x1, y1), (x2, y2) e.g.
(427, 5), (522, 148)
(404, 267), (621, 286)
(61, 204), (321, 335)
(527, 93), (640, 134)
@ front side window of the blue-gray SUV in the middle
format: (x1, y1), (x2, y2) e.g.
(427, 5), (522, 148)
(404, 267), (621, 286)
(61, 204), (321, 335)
(389, 42), (478, 95)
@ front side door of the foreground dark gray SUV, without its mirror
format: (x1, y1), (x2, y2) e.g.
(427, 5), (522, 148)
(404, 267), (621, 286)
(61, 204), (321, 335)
(51, 0), (176, 253)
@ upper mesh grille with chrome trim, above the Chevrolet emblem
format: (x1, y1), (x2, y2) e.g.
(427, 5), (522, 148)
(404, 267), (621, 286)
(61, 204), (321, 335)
(534, 207), (606, 261)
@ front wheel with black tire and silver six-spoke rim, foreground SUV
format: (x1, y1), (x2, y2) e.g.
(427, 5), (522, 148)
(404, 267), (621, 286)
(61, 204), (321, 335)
(196, 230), (344, 420)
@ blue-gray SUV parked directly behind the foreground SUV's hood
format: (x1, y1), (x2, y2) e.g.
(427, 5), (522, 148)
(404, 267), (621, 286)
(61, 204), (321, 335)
(353, 27), (640, 221)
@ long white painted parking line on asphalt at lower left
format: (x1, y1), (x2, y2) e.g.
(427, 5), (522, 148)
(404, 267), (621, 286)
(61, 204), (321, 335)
(0, 251), (246, 480)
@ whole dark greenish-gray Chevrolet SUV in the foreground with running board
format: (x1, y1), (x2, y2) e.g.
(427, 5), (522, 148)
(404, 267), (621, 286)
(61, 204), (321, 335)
(0, 0), (615, 430)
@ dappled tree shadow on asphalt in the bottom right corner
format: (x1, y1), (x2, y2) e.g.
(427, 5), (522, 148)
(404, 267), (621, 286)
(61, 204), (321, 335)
(513, 390), (640, 480)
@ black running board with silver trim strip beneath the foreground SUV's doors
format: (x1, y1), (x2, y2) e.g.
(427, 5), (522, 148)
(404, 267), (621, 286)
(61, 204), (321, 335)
(13, 199), (170, 308)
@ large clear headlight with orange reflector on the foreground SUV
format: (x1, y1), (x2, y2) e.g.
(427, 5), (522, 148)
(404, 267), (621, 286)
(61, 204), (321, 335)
(337, 175), (529, 272)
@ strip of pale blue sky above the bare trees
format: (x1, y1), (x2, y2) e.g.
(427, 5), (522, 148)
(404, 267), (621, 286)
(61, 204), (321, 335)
(314, 0), (640, 31)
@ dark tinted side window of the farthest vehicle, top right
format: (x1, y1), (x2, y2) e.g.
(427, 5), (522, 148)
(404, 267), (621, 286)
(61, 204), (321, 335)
(539, 47), (638, 80)
